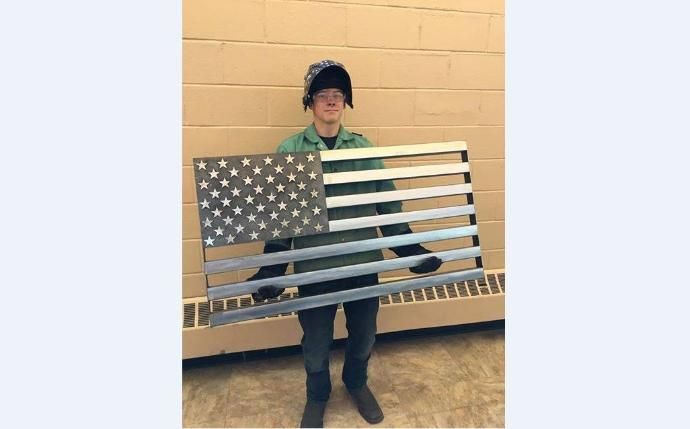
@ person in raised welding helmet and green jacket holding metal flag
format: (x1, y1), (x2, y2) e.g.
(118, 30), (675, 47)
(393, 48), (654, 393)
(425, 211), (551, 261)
(248, 60), (442, 427)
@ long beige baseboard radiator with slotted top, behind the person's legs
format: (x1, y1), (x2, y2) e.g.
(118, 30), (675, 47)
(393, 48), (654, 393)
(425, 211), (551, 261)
(182, 270), (506, 359)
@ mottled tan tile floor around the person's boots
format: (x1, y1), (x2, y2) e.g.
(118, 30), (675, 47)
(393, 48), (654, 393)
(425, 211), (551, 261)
(182, 321), (505, 428)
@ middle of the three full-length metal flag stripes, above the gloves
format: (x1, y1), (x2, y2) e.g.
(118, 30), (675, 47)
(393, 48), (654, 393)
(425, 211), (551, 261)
(208, 247), (482, 301)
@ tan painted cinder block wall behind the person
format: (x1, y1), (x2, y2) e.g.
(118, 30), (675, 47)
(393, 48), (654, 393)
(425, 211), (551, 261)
(182, 0), (505, 298)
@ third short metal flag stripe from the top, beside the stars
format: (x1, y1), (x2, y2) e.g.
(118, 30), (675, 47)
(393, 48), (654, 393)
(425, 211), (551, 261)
(326, 183), (472, 209)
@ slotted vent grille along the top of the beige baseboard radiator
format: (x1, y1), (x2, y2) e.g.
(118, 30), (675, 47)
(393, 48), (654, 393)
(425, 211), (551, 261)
(182, 272), (505, 329)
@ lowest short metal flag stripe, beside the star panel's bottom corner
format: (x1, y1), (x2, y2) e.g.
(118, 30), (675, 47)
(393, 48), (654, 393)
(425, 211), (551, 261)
(328, 204), (475, 232)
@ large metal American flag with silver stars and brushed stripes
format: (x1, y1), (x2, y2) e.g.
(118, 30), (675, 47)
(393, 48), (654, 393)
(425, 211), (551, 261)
(194, 142), (484, 326)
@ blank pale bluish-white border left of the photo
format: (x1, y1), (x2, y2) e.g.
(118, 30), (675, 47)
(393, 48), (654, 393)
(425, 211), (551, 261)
(0, 1), (182, 428)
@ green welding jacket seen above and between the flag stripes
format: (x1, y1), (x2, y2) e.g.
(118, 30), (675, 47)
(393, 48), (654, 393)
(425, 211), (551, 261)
(266, 124), (409, 273)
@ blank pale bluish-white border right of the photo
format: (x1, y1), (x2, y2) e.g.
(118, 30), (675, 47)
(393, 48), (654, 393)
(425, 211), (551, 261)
(506, 0), (690, 428)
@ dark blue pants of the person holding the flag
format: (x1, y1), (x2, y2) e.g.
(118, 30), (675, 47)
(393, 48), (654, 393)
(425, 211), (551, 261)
(297, 276), (379, 401)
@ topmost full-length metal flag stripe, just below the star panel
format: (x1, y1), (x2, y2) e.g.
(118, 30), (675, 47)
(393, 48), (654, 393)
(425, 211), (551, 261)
(204, 222), (478, 274)
